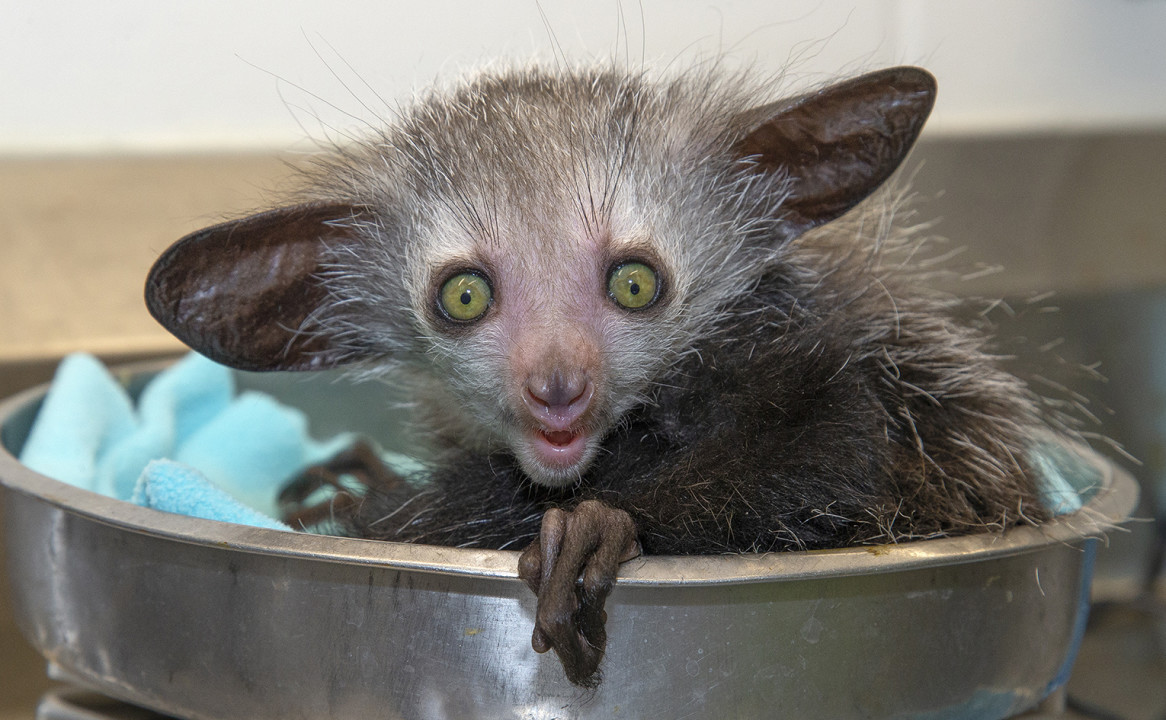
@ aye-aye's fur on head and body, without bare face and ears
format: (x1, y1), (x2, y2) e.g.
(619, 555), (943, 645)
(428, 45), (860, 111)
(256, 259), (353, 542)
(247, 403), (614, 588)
(286, 68), (1046, 553)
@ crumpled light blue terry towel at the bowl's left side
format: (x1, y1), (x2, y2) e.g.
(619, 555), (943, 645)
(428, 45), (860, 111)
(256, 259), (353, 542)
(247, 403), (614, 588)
(21, 354), (352, 529)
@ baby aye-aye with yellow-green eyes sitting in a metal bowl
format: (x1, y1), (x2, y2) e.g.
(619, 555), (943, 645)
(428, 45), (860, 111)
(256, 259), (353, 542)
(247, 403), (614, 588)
(147, 68), (1047, 685)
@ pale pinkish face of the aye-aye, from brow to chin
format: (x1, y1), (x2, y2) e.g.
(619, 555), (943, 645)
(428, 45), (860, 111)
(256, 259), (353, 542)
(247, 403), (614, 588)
(410, 177), (694, 485)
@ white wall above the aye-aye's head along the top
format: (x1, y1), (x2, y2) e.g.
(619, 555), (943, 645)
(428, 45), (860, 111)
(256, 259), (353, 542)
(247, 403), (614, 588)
(0, 0), (1166, 153)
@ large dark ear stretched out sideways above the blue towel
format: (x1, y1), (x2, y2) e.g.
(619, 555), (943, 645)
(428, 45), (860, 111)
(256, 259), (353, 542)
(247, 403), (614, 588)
(146, 204), (366, 370)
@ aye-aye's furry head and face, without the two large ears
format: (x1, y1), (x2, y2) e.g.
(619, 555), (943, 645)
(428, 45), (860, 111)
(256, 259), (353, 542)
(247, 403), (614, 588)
(340, 74), (797, 485)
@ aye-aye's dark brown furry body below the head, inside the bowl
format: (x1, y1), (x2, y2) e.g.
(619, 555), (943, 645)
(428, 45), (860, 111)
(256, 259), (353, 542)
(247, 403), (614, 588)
(344, 263), (1047, 554)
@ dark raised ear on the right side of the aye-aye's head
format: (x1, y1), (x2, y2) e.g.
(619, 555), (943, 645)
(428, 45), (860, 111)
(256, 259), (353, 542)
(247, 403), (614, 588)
(733, 68), (935, 239)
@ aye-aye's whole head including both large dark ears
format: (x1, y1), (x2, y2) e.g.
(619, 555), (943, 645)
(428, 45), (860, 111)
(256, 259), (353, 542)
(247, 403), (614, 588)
(147, 68), (934, 485)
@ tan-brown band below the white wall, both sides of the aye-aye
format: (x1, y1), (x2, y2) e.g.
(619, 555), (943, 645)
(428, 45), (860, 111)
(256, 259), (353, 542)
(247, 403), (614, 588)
(0, 132), (1166, 363)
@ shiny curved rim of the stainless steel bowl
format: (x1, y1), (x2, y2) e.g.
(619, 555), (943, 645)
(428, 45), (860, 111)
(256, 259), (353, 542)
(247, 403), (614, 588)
(0, 362), (1138, 587)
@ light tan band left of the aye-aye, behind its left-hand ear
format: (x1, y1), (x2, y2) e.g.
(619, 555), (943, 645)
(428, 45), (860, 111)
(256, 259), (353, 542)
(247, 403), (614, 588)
(0, 155), (290, 363)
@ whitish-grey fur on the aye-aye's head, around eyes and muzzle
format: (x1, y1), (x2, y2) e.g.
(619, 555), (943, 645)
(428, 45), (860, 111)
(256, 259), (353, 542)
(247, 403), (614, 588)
(296, 68), (785, 471)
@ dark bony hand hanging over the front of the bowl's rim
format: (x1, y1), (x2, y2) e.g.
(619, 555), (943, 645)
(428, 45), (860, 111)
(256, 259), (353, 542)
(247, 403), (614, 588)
(519, 501), (640, 687)
